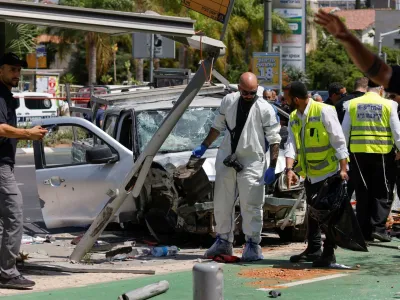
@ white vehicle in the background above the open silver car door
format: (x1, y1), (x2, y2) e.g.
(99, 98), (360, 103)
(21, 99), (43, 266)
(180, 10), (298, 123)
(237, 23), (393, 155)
(13, 92), (58, 123)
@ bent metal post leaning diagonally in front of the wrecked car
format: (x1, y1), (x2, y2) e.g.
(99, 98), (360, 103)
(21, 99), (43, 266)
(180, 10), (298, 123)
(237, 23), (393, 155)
(70, 37), (225, 262)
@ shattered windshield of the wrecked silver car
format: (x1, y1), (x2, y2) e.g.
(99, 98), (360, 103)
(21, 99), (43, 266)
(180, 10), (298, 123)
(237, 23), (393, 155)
(136, 107), (223, 153)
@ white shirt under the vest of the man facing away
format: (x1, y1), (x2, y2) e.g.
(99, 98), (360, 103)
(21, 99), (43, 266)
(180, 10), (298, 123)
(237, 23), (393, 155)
(342, 92), (400, 149)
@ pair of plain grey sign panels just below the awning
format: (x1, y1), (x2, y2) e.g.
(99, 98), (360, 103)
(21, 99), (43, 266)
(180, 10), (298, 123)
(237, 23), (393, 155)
(132, 32), (175, 59)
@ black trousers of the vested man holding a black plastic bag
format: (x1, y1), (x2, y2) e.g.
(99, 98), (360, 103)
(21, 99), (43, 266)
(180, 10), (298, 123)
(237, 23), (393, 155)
(304, 179), (336, 255)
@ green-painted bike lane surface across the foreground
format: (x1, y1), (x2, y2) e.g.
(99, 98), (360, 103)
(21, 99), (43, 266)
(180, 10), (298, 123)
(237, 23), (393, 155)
(3, 244), (400, 300)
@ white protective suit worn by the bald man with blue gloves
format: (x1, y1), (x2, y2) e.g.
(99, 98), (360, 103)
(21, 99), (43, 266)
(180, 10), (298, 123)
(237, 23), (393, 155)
(212, 92), (281, 243)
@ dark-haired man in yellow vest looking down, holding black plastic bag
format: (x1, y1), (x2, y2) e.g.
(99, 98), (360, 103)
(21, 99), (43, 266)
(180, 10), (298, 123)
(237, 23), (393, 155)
(285, 82), (349, 267)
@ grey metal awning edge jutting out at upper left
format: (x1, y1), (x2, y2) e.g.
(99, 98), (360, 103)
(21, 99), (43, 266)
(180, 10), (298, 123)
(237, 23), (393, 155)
(0, 0), (195, 37)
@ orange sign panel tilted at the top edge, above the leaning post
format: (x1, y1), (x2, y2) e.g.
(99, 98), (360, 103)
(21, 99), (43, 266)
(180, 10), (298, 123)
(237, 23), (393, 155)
(182, 0), (233, 23)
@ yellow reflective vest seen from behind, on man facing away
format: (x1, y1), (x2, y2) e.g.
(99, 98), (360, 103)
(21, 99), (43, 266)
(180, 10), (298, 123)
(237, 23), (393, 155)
(349, 92), (393, 154)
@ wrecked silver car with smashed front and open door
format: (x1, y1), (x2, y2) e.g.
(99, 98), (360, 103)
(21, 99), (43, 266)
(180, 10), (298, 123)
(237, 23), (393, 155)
(35, 88), (305, 241)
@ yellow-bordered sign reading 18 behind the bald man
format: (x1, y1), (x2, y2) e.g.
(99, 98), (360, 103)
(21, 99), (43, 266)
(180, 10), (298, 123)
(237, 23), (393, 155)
(252, 52), (282, 90)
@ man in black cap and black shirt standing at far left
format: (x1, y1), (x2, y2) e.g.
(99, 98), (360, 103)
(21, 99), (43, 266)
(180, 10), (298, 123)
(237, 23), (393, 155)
(0, 53), (47, 289)
